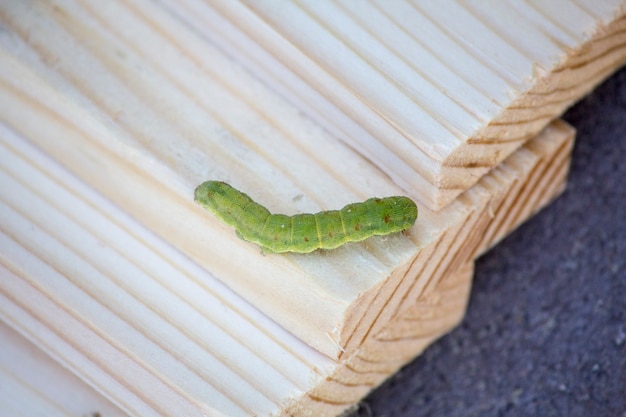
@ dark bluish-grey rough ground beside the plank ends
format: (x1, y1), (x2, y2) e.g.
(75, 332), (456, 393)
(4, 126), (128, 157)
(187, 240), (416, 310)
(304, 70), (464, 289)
(352, 68), (626, 417)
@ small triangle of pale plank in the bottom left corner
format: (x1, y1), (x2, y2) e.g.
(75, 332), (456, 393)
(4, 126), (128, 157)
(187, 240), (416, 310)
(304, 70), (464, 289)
(0, 321), (127, 417)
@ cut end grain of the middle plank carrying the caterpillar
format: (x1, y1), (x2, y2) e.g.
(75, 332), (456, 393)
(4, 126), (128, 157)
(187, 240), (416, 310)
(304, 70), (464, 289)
(340, 122), (574, 354)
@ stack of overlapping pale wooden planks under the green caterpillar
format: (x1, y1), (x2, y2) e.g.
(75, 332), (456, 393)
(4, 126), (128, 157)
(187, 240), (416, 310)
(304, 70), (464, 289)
(0, 0), (626, 416)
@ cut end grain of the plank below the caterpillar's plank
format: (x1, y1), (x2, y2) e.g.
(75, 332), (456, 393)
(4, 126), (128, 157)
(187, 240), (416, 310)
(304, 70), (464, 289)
(281, 262), (474, 417)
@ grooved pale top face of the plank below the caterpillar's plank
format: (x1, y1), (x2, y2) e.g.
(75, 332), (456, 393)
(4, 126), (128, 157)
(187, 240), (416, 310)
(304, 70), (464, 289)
(0, 129), (332, 416)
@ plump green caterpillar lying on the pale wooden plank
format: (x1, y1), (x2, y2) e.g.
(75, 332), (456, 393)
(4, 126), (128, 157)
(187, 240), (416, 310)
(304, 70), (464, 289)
(194, 181), (417, 253)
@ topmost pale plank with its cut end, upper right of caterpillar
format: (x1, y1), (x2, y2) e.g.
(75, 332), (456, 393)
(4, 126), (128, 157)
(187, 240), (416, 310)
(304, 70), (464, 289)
(186, 0), (626, 209)
